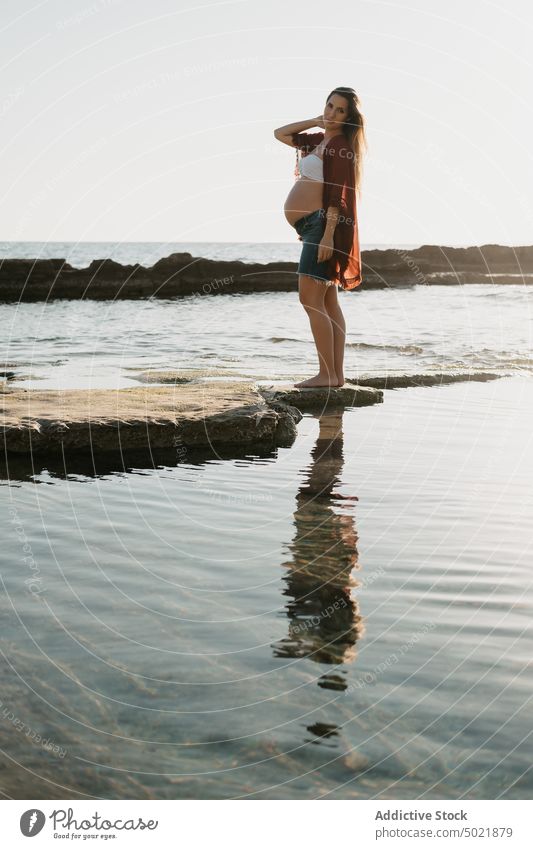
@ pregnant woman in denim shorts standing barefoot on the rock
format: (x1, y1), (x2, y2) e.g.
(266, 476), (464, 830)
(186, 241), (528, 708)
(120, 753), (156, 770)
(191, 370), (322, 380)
(274, 86), (366, 387)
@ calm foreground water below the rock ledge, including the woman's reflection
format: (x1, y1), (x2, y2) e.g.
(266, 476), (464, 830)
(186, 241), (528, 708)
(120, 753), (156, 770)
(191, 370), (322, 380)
(0, 376), (533, 799)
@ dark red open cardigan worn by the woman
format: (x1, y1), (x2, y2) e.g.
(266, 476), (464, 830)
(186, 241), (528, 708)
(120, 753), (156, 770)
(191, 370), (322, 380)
(292, 132), (362, 289)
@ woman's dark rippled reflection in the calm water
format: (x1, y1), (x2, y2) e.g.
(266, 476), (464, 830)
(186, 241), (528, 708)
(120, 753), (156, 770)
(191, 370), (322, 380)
(273, 410), (364, 690)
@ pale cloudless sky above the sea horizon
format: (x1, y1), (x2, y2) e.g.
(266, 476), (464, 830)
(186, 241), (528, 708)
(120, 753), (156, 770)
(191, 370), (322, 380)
(0, 0), (533, 248)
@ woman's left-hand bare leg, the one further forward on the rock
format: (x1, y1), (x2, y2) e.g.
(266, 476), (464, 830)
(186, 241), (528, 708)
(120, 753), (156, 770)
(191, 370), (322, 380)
(294, 274), (338, 388)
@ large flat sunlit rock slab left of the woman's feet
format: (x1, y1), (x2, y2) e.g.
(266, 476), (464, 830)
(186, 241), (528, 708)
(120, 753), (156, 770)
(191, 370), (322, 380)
(0, 381), (301, 453)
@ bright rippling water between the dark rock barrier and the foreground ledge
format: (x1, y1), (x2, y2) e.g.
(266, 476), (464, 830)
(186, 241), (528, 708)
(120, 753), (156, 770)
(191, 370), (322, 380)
(0, 284), (533, 389)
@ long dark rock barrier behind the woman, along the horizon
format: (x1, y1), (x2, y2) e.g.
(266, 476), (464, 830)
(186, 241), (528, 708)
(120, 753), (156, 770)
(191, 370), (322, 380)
(0, 245), (533, 302)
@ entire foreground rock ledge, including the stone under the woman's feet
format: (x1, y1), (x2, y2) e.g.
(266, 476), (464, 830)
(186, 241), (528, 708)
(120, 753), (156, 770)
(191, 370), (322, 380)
(0, 372), (499, 459)
